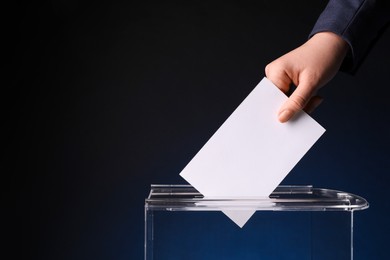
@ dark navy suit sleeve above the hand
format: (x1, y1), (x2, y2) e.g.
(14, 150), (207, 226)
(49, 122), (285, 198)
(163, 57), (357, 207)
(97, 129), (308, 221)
(310, 0), (390, 73)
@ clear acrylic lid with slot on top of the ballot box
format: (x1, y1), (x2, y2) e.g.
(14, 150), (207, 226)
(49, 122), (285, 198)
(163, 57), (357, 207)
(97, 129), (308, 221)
(145, 184), (369, 211)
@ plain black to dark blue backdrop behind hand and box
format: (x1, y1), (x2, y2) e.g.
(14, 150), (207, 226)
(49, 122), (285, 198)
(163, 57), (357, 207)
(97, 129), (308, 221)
(10, 0), (390, 259)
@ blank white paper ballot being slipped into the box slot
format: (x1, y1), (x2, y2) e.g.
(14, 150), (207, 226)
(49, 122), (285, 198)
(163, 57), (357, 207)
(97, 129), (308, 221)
(180, 78), (325, 227)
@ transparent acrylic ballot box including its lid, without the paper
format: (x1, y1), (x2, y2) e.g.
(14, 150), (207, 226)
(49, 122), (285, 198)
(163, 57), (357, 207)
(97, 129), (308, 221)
(145, 185), (368, 260)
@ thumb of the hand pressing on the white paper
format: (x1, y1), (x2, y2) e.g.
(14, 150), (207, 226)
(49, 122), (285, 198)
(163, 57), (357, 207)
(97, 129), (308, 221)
(278, 82), (314, 123)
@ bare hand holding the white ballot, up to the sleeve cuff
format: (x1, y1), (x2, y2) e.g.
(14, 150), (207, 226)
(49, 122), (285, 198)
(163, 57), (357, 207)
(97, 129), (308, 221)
(265, 32), (349, 123)
